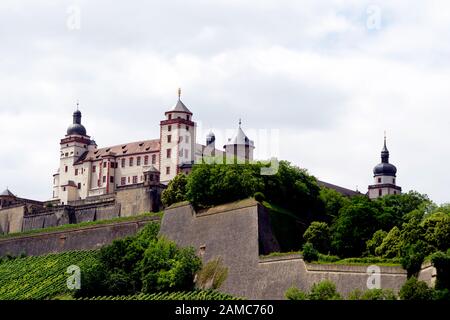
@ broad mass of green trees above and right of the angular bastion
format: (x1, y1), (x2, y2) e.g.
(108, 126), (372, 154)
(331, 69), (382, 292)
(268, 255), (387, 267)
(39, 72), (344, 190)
(165, 161), (450, 276)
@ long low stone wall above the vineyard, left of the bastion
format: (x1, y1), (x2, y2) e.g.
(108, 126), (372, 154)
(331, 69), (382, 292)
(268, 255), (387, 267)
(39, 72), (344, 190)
(0, 217), (159, 256)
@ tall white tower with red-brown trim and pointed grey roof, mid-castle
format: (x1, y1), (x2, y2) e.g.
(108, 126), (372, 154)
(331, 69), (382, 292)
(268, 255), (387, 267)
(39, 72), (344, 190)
(159, 89), (196, 184)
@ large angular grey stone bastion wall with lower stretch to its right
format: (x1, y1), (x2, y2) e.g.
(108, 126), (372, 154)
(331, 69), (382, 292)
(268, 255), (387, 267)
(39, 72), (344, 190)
(160, 200), (406, 299)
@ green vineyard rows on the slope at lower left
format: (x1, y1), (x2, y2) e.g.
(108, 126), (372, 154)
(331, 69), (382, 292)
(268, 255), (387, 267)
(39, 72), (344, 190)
(0, 251), (97, 300)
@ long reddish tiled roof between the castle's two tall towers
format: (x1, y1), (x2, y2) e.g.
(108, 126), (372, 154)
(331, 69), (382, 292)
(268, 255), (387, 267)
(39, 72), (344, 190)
(75, 139), (161, 164)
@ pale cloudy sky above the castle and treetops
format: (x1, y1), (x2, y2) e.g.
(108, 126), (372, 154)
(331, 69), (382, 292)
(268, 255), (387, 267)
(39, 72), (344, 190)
(0, 0), (450, 203)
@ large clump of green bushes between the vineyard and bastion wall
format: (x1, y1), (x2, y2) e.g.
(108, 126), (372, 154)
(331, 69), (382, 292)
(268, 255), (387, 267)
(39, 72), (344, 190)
(77, 223), (201, 296)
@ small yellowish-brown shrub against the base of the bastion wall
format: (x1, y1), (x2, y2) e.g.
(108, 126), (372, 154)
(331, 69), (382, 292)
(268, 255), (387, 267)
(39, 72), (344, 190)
(196, 257), (228, 290)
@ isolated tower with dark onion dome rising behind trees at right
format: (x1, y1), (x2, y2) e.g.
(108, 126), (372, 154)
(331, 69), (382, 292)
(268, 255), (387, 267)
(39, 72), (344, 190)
(369, 134), (402, 199)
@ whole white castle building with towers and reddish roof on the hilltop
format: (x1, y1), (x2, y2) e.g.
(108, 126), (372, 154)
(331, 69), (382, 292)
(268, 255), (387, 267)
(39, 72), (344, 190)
(53, 90), (255, 204)
